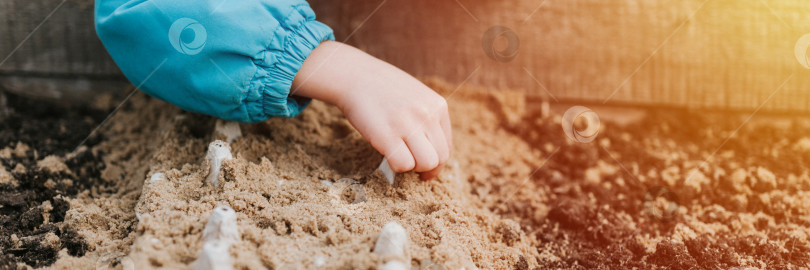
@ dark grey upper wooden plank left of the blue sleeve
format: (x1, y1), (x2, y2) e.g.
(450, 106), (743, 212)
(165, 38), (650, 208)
(0, 0), (122, 78)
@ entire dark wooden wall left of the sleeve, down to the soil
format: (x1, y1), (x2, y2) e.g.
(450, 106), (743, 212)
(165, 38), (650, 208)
(0, 0), (128, 102)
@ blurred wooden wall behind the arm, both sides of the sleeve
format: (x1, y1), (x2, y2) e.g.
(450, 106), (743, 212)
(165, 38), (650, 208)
(0, 0), (810, 113)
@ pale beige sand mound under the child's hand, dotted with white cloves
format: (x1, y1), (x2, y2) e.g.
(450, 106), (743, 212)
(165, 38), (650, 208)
(55, 79), (538, 269)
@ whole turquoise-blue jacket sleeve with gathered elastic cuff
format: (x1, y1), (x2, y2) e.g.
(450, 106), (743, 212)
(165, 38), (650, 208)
(95, 0), (334, 122)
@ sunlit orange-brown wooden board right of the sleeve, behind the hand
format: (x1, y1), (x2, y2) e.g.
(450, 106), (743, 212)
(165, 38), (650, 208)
(311, 0), (810, 112)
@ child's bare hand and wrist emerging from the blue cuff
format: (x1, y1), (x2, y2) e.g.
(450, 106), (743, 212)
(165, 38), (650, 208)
(291, 41), (453, 180)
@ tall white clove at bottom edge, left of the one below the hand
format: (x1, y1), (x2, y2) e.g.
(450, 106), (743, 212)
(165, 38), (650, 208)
(194, 206), (240, 270)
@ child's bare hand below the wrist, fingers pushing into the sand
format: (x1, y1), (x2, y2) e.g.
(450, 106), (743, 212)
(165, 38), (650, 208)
(338, 59), (452, 180)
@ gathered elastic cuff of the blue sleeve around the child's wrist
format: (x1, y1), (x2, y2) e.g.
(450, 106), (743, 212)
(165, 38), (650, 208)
(250, 17), (335, 122)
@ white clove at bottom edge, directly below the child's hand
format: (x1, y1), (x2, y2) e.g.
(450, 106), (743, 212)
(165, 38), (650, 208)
(374, 221), (411, 269)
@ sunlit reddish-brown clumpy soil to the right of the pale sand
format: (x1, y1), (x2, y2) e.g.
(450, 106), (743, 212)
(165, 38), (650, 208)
(492, 97), (810, 269)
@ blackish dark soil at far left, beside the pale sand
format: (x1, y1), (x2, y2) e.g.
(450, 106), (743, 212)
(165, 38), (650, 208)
(0, 91), (107, 269)
